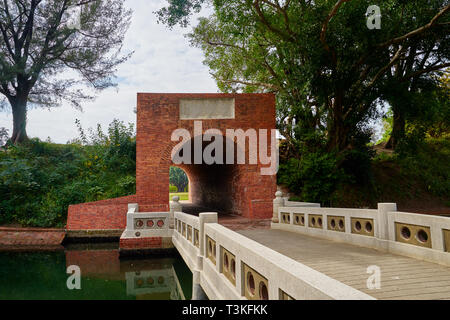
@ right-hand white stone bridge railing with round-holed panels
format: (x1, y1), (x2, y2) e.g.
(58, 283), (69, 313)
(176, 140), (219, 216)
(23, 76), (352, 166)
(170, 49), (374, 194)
(272, 199), (450, 265)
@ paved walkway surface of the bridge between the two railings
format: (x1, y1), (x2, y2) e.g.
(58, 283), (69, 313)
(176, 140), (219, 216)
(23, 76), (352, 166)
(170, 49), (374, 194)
(237, 229), (450, 300)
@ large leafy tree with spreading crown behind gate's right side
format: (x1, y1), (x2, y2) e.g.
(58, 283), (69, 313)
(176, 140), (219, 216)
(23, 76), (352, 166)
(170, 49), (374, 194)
(159, 0), (450, 153)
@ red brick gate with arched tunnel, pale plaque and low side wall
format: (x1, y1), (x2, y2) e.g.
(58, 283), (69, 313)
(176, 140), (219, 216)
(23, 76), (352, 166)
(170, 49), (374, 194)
(67, 93), (276, 231)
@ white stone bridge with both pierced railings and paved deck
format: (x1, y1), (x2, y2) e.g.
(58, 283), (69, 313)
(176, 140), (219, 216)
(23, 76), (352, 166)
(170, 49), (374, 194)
(121, 192), (450, 300)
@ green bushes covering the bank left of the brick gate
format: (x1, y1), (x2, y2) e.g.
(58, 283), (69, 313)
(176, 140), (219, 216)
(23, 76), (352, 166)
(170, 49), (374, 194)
(0, 120), (136, 227)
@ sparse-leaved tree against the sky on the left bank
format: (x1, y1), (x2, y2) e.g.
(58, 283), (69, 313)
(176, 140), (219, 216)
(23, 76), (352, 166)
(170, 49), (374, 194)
(0, 0), (131, 143)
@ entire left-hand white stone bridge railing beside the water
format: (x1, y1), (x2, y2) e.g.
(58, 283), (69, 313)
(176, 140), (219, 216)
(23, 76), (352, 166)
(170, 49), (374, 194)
(172, 212), (372, 300)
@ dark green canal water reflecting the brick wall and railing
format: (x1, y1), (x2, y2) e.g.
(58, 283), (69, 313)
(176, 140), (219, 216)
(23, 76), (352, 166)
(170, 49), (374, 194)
(0, 243), (192, 300)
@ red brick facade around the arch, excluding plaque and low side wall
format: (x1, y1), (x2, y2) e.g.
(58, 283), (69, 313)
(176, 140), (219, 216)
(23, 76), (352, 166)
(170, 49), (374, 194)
(136, 93), (276, 218)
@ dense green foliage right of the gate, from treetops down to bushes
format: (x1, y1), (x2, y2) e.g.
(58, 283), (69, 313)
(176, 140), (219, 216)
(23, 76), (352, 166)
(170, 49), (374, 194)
(159, 0), (450, 206)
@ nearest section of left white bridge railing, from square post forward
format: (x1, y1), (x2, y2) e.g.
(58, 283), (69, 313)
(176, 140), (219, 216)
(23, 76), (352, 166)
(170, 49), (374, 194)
(201, 223), (373, 300)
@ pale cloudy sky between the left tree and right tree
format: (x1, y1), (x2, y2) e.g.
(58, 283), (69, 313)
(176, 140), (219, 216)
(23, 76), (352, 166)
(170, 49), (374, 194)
(0, 0), (218, 143)
